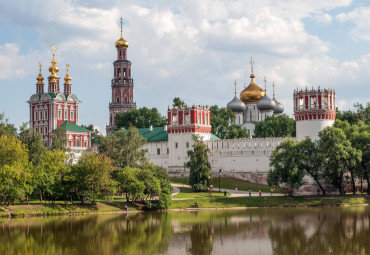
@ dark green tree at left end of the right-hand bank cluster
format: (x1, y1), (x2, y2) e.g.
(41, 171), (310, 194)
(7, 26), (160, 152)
(267, 139), (305, 193)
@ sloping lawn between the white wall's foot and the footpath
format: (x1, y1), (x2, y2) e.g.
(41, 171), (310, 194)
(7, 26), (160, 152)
(170, 177), (284, 193)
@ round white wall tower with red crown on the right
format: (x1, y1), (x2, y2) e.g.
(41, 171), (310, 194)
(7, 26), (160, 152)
(293, 87), (335, 141)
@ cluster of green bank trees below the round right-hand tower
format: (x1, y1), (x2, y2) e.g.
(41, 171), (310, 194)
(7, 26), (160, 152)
(268, 104), (370, 195)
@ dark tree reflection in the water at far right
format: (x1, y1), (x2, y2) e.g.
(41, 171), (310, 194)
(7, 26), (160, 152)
(269, 209), (370, 254)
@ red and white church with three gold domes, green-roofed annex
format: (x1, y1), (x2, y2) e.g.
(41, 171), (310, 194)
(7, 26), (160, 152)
(28, 44), (91, 150)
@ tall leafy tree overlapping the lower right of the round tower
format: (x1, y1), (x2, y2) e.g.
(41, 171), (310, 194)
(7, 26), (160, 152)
(319, 127), (362, 195)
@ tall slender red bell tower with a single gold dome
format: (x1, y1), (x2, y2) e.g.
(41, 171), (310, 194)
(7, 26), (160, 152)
(106, 18), (136, 135)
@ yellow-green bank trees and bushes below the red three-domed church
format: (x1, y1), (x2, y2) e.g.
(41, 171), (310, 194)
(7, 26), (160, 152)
(0, 114), (172, 209)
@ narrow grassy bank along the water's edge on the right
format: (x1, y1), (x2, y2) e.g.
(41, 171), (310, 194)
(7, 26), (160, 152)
(169, 196), (370, 209)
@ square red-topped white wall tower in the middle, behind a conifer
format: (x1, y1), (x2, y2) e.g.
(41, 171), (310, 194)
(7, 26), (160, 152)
(167, 105), (211, 172)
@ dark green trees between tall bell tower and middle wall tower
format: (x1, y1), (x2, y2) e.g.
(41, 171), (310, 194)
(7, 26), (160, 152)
(116, 107), (167, 129)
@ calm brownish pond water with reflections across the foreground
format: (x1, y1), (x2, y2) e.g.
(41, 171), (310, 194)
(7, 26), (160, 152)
(0, 207), (370, 255)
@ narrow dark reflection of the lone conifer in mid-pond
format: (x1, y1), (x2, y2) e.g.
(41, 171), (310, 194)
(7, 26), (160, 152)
(189, 223), (213, 255)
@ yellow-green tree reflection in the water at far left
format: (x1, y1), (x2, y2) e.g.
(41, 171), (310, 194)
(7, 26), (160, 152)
(0, 214), (172, 255)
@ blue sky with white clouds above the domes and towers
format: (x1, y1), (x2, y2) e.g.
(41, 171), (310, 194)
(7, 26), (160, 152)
(0, 0), (370, 135)
